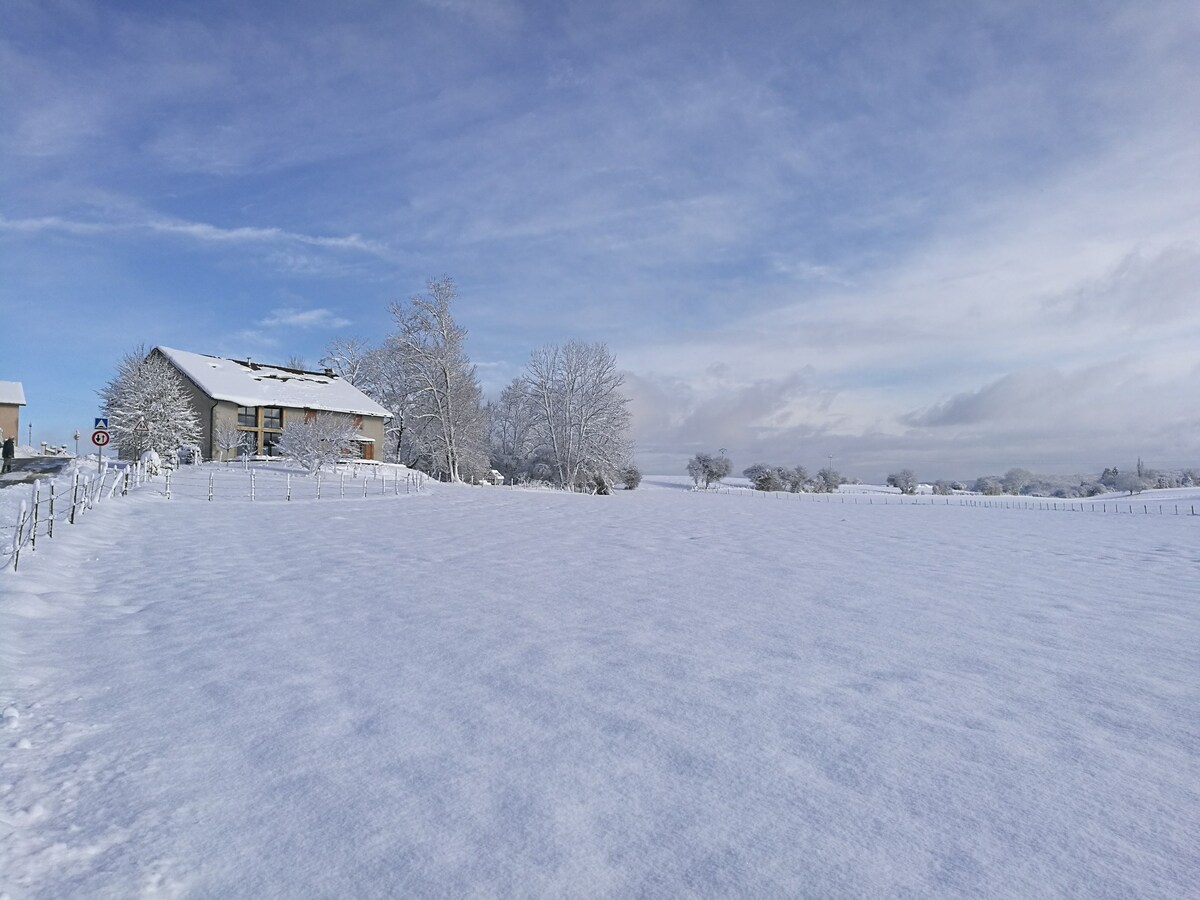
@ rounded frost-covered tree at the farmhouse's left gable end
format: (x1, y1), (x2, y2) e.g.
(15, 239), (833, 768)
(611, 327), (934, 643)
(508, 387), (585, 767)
(98, 347), (200, 460)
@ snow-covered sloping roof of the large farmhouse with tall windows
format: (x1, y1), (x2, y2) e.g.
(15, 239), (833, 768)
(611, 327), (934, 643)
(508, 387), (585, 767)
(155, 347), (391, 416)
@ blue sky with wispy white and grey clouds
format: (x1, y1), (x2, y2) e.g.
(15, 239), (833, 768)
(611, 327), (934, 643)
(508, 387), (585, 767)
(0, 0), (1200, 479)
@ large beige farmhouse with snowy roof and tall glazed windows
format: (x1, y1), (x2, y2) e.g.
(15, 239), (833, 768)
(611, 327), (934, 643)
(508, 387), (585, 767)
(151, 347), (390, 460)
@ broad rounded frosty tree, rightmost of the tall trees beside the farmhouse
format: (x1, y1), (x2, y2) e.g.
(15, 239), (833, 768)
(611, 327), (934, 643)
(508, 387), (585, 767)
(521, 341), (630, 493)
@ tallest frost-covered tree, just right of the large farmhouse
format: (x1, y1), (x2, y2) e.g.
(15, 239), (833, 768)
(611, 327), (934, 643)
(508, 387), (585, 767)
(379, 277), (488, 481)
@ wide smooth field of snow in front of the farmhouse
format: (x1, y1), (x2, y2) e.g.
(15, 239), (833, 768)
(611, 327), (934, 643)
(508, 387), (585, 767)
(0, 468), (1200, 900)
